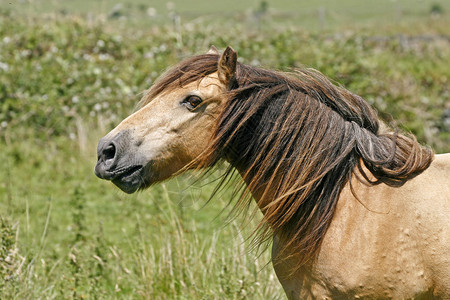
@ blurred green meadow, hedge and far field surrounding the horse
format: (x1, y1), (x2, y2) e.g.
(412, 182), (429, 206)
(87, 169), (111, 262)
(0, 0), (450, 299)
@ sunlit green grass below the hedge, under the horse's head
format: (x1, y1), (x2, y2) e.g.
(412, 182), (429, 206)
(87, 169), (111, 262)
(0, 135), (282, 299)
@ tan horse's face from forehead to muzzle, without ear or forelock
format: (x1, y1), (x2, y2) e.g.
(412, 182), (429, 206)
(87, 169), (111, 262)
(95, 73), (224, 193)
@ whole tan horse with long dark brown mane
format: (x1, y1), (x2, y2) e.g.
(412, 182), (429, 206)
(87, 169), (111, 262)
(95, 47), (450, 299)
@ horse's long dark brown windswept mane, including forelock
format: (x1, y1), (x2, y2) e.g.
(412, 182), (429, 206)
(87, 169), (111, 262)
(141, 54), (433, 266)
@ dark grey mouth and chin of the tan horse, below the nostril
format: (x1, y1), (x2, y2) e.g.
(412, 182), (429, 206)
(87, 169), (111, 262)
(111, 165), (144, 194)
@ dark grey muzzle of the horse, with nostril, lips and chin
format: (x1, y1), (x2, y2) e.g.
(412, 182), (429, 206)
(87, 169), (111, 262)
(94, 131), (143, 194)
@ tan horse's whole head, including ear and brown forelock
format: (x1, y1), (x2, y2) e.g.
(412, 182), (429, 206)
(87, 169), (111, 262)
(95, 47), (237, 193)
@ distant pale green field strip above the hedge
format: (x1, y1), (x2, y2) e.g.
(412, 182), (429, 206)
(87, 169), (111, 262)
(7, 0), (450, 30)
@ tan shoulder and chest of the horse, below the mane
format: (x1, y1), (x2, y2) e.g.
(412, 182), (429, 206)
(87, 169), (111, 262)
(273, 154), (450, 299)
